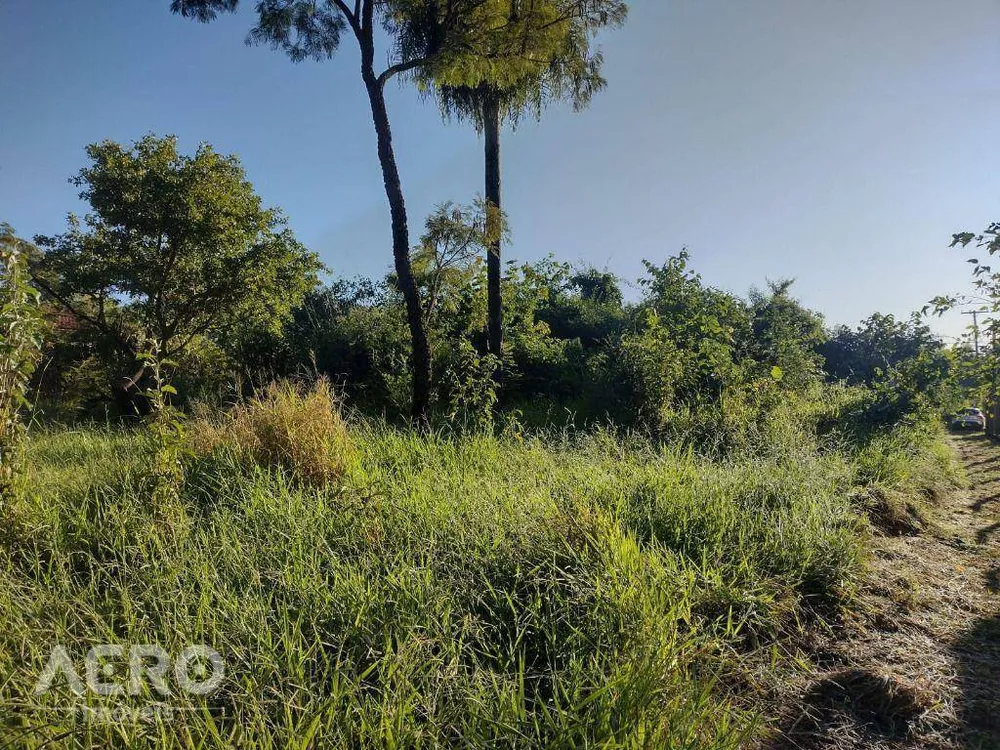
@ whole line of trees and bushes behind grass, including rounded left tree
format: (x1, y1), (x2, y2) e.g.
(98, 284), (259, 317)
(25, 136), (961, 440)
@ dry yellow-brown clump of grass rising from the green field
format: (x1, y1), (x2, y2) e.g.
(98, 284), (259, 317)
(192, 379), (355, 485)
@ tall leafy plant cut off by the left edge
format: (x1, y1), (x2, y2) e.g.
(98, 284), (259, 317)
(0, 224), (42, 503)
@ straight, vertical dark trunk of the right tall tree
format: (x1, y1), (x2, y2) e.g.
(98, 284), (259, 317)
(483, 92), (503, 357)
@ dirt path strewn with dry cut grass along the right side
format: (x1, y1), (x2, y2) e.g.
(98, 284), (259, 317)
(778, 435), (1000, 750)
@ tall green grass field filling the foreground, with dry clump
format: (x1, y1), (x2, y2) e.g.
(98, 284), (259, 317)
(0, 390), (958, 748)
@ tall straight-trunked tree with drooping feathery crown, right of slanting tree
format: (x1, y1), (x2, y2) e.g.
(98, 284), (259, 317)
(421, 0), (628, 357)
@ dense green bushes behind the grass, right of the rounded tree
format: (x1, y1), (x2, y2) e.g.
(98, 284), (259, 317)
(225, 247), (954, 440)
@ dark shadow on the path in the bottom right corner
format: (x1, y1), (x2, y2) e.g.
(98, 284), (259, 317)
(952, 616), (1000, 750)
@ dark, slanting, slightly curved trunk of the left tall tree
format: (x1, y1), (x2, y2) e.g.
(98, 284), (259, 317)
(362, 71), (431, 428)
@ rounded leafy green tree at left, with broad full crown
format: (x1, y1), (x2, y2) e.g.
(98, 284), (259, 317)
(32, 135), (322, 418)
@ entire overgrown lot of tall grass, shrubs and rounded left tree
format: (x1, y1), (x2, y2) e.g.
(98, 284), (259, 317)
(0, 128), (969, 748)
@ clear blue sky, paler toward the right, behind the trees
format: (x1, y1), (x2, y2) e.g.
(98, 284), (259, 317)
(0, 0), (1000, 334)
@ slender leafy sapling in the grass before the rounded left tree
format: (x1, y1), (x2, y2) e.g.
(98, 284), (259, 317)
(139, 340), (184, 507)
